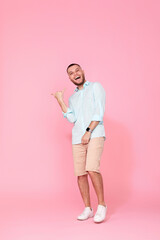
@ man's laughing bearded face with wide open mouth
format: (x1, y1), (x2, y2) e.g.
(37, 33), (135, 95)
(68, 65), (85, 86)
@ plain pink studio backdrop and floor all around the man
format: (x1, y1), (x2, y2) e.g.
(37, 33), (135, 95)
(0, 0), (160, 240)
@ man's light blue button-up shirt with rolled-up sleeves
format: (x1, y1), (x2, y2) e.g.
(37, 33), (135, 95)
(62, 81), (106, 144)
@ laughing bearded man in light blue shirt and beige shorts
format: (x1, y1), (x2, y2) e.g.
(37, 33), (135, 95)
(53, 63), (107, 223)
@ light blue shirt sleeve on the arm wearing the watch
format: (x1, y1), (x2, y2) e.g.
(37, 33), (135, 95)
(92, 82), (106, 121)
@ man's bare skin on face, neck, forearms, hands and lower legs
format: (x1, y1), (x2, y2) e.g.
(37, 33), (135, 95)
(51, 65), (106, 211)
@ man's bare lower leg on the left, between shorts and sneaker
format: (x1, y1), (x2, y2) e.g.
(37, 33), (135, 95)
(77, 174), (91, 210)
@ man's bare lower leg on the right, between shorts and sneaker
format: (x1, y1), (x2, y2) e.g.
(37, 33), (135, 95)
(88, 171), (106, 206)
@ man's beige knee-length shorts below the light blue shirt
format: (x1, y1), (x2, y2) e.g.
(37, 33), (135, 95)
(72, 137), (105, 176)
